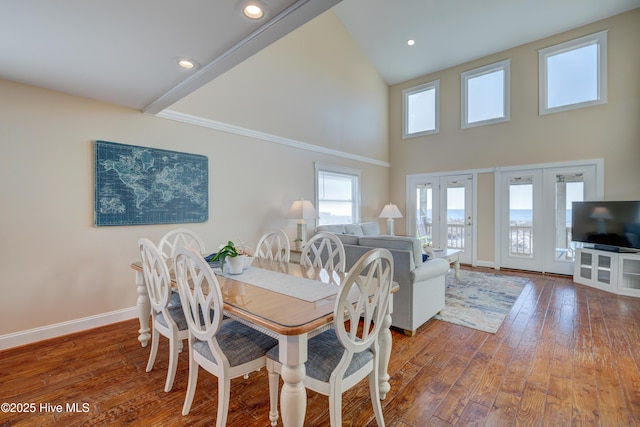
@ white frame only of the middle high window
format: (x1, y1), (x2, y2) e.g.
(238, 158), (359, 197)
(460, 59), (511, 129)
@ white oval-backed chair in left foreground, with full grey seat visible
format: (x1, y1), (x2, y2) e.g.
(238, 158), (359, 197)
(175, 247), (278, 427)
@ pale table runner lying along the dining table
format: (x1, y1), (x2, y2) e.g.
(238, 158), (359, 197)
(216, 267), (339, 302)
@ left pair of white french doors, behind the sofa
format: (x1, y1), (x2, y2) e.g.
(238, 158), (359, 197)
(407, 174), (474, 264)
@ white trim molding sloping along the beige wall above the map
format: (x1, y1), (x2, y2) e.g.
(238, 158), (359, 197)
(156, 110), (389, 168)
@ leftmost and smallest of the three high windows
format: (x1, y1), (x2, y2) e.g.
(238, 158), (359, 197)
(402, 80), (440, 138)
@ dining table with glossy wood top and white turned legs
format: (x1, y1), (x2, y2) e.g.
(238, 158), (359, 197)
(131, 258), (398, 427)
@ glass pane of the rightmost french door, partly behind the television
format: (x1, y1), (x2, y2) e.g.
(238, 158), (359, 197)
(555, 174), (584, 261)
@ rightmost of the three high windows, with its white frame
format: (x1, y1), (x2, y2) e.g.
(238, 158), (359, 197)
(538, 31), (607, 115)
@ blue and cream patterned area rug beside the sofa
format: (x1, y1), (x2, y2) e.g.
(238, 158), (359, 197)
(434, 270), (529, 334)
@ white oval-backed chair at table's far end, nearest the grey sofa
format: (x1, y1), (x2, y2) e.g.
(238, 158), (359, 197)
(300, 232), (346, 272)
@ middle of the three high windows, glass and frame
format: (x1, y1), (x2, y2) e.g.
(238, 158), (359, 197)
(460, 60), (510, 129)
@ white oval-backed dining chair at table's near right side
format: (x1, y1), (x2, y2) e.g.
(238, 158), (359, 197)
(267, 248), (393, 427)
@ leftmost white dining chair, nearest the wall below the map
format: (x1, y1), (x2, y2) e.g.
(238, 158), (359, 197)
(138, 237), (189, 392)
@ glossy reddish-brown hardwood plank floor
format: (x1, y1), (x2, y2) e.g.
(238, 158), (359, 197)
(0, 269), (640, 427)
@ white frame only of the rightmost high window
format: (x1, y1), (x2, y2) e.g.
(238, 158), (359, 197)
(538, 30), (607, 116)
